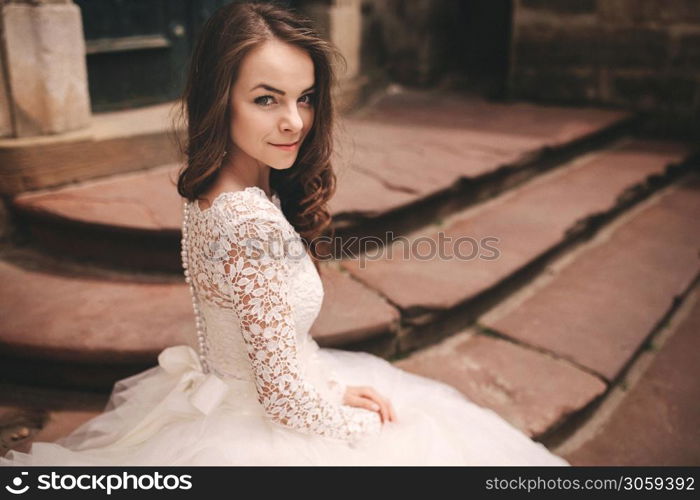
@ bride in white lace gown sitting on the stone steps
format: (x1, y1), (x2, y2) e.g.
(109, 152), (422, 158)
(0, 3), (569, 465)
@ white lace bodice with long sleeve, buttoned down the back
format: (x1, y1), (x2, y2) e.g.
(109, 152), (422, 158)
(183, 187), (381, 442)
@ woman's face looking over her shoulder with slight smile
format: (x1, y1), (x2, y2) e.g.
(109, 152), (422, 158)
(230, 40), (315, 169)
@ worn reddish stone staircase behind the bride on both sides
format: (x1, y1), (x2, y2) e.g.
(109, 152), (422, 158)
(0, 87), (700, 464)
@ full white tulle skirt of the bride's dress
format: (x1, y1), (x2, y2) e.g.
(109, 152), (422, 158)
(0, 346), (569, 466)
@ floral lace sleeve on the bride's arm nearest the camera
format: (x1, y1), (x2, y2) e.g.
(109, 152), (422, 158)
(215, 197), (381, 443)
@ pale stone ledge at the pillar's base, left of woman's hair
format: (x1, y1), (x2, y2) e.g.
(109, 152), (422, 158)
(0, 102), (182, 194)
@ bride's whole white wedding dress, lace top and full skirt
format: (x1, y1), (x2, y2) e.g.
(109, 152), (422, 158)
(0, 187), (569, 466)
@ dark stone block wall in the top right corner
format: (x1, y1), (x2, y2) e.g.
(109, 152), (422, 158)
(508, 0), (700, 138)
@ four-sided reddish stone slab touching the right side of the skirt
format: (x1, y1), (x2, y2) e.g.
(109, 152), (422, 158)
(394, 329), (606, 437)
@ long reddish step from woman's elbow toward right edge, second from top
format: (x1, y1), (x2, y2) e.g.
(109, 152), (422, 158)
(342, 139), (690, 350)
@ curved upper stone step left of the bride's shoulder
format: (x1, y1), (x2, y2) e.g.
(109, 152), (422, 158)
(12, 164), (182, 272)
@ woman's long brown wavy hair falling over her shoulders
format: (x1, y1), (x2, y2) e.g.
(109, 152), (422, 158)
(176, 2), (346, 270)
